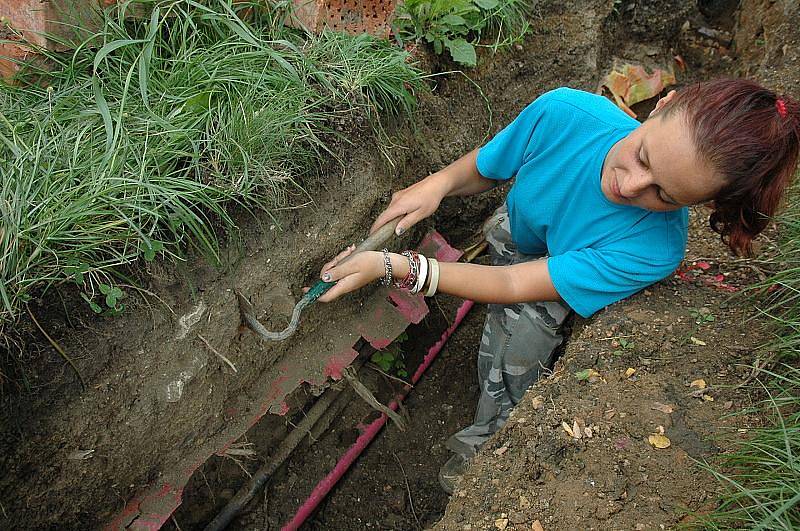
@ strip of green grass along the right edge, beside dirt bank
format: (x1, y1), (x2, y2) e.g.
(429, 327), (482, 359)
(698, 188), (800, 530)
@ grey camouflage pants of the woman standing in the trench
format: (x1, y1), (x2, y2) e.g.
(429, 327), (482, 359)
(446, 204), (571, 458)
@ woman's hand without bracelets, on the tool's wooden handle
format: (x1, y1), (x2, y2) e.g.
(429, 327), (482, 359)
(369, 174), (447, 236)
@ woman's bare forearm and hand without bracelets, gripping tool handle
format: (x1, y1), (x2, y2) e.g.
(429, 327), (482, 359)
(369, 149), (496, 234)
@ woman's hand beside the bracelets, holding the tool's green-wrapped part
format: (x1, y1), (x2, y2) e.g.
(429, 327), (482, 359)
(312, 249), (384, 302)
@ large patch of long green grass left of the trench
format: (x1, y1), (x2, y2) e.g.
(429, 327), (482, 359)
(0, 0), (422, 333)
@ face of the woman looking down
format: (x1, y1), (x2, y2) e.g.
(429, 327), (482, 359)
(600, 112), (724, 212)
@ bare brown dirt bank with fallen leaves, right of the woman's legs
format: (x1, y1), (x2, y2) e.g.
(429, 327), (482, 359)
(437, 212), (766, 530)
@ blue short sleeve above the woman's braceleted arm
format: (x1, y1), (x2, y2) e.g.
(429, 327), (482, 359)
(547, 248), (682, 317)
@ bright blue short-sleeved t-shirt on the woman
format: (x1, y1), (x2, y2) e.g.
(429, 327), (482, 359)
(477, 88), (688, 317)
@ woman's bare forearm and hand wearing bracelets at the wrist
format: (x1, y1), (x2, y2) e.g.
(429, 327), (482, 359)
(319, 251), (559, 304)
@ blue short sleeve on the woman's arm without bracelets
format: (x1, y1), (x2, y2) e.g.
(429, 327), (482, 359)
(477, 93), (550, 181)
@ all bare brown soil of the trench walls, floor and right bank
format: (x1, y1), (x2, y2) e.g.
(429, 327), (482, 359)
(0, 0), (800, 530)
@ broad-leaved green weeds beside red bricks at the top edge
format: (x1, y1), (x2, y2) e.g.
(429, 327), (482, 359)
(394, 0), (533, 66)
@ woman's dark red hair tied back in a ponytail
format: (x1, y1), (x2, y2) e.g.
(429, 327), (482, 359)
(663, 79), (800, 254)
